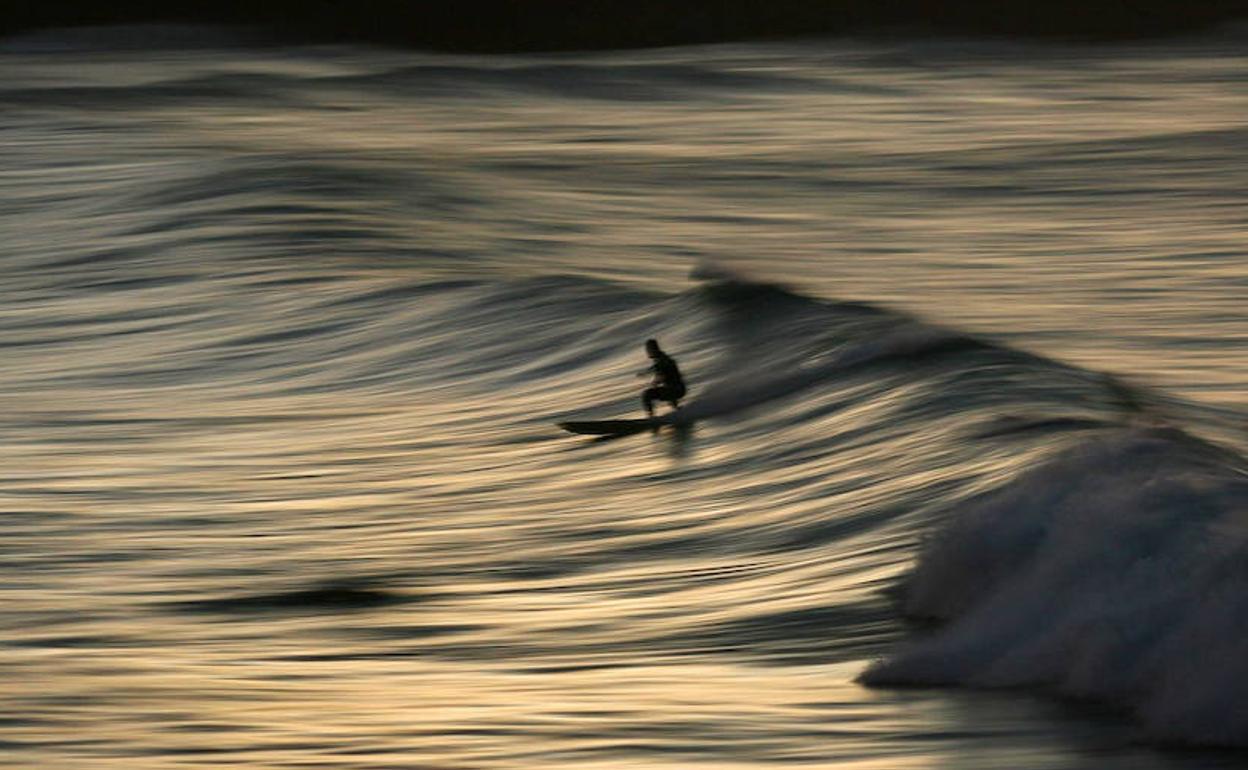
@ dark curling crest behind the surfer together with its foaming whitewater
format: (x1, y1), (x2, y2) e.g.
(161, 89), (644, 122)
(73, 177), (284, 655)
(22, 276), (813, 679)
(653, 272), (1248, 746)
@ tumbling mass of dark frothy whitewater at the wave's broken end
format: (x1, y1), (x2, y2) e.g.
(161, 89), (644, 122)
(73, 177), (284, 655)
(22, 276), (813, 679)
(862, 428), (1248, 746)
